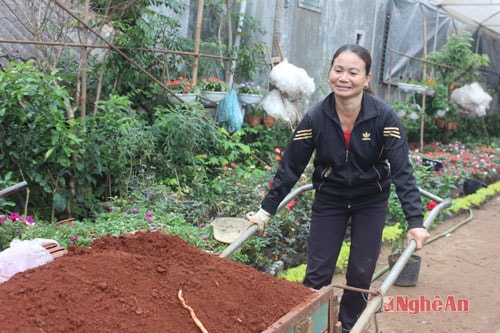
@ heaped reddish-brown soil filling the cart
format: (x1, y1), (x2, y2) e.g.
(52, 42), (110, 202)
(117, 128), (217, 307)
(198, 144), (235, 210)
(0, 232), (315, 333)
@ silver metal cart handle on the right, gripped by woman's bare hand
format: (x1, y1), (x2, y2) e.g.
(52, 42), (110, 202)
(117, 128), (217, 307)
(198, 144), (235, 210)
(351, 196), (451, 333)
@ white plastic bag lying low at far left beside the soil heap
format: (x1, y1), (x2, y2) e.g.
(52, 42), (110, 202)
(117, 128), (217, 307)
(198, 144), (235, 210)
(0, 238), (57, 283)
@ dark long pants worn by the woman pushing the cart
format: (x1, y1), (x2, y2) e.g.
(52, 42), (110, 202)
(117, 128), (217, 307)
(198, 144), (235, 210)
(304, 200), (387, 330)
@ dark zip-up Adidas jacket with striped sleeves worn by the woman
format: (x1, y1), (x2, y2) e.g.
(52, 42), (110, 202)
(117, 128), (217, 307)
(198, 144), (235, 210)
(261, 92), (423, 228)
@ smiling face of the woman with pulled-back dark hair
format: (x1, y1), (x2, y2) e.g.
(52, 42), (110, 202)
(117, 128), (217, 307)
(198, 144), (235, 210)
(328, 51), (372, 98)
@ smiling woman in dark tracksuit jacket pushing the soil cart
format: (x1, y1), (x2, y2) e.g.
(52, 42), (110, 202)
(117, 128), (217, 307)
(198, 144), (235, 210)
(247, 44), (429, 331)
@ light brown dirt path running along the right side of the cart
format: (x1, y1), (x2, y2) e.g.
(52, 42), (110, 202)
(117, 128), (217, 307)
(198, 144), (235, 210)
(366, 196), (500, 333)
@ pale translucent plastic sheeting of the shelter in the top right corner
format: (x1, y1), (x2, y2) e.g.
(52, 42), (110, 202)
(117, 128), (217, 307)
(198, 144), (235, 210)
(382, 0), (500, 92)
